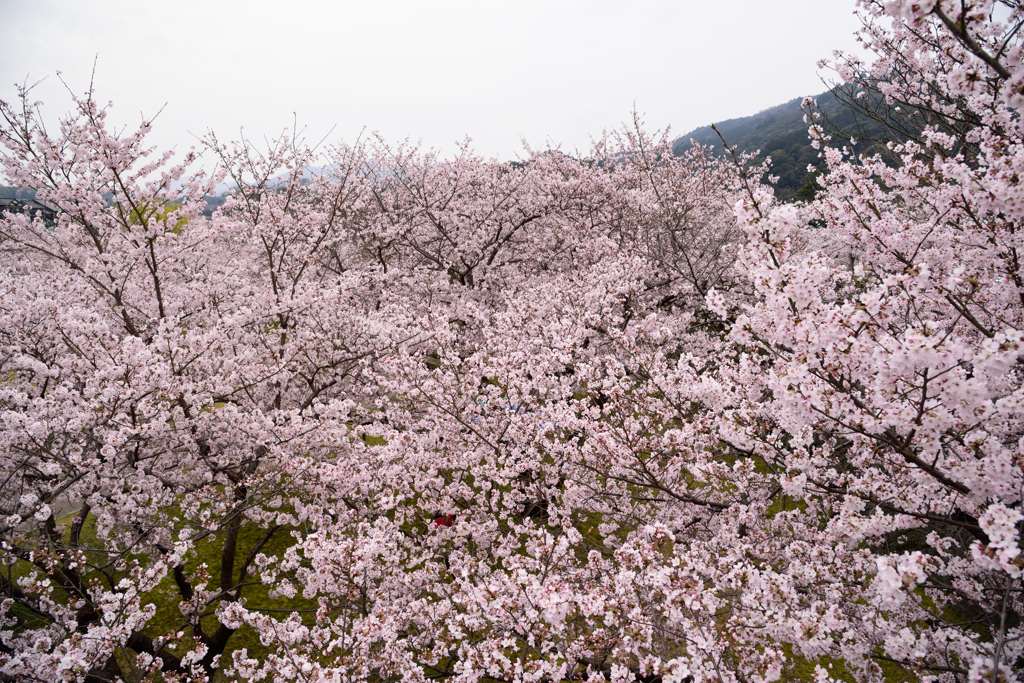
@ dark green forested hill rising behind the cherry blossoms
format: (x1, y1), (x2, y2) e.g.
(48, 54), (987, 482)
(672, 91), (884, 199)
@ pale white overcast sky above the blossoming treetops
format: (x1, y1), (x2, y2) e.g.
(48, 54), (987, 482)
(0, 0), (858, 158)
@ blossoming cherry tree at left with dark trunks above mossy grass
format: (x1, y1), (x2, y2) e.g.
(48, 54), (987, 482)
(0, 83), (416, 680)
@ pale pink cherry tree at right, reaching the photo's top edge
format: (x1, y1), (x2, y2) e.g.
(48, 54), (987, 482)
(688, 2), (1024, 680)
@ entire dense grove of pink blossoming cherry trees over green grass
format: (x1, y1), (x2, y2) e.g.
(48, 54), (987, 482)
(0, 0), (1024, 683)
